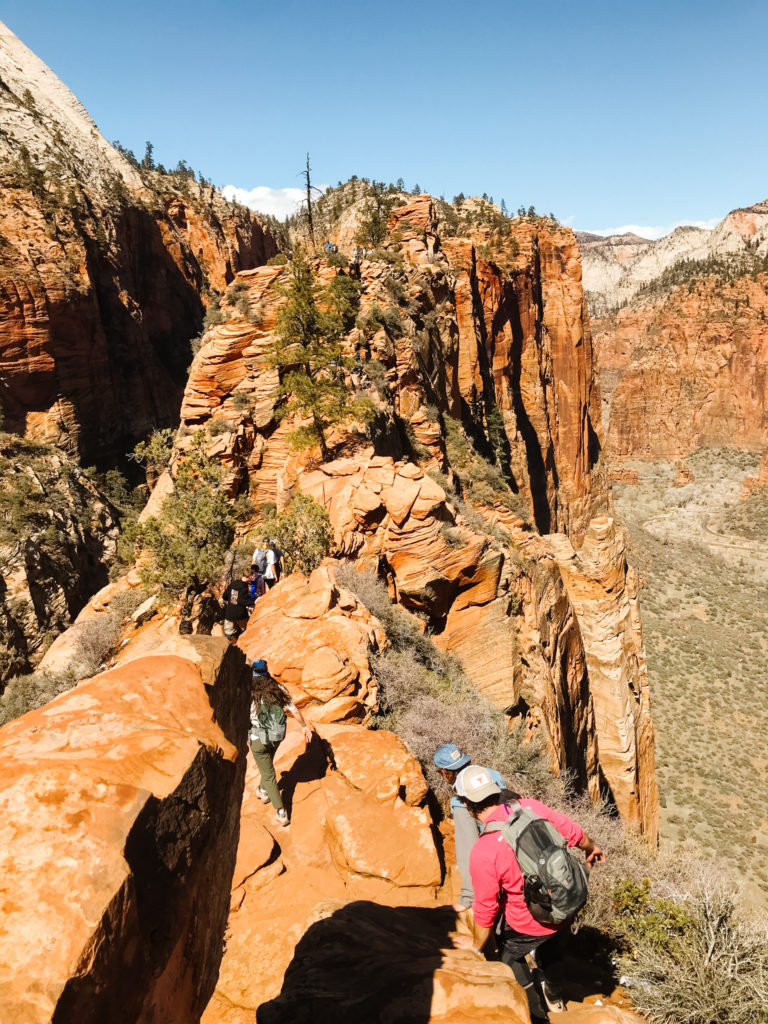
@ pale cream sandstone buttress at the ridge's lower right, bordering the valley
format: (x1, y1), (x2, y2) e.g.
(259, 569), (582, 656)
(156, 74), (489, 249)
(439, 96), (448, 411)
(547, 516), (658, 843)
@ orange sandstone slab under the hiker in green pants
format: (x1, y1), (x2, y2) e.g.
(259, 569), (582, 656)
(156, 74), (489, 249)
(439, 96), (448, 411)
(204, 721), (444, 1024)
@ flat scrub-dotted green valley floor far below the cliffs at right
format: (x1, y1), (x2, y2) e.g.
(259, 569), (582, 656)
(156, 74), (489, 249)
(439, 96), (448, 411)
(614, 450), (768, 905)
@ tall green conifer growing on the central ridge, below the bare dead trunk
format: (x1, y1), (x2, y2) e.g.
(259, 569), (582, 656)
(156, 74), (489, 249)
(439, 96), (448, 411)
(269, 250), (373, 462)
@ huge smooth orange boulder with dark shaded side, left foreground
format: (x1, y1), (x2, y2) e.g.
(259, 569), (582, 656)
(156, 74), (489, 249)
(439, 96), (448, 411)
(0, 638), (248, 1024)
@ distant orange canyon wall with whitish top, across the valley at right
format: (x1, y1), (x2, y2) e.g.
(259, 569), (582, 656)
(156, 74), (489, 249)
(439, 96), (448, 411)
(580, 195), (768, 462)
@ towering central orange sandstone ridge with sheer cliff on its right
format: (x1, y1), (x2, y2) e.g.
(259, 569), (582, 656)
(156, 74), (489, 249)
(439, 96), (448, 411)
(171, 196), (655, 837)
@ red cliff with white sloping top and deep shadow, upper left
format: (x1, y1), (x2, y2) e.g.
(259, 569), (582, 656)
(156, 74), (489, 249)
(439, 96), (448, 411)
(0, 26), (276, 462)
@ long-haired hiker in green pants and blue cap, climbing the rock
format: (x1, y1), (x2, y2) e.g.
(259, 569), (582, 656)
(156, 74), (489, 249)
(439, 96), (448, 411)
(249, 658), (314, 828)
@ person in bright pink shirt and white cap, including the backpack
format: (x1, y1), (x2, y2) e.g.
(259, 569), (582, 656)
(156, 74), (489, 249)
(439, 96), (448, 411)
(454, 765), (605, 1024)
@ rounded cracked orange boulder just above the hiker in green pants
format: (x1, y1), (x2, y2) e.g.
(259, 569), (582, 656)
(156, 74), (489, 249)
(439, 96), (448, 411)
(238, 566), (387, 722)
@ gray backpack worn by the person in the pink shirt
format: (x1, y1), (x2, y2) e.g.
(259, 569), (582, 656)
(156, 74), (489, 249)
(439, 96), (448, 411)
(480, 804), (588, 925)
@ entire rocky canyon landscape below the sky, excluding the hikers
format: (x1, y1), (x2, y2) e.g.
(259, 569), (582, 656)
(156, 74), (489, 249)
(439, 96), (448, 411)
(0, 24), (768, 1024)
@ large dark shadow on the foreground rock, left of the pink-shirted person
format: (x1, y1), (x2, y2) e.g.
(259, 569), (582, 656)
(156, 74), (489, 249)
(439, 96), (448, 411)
(256, 901), (457, 1024)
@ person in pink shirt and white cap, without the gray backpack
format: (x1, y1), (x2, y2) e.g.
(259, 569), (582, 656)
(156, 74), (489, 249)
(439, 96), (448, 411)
(454, 765), (605, 1024)
